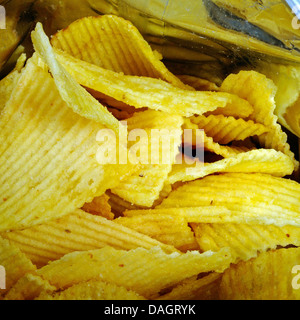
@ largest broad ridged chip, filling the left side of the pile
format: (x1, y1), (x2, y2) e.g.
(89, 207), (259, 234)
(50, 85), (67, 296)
(0, 58), (137, 231)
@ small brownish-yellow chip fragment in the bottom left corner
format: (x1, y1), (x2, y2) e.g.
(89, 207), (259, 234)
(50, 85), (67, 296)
(4, 273), (55, 301)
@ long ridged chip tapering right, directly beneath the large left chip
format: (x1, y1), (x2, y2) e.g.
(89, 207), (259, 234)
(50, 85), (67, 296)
(2, 210), (177, 267)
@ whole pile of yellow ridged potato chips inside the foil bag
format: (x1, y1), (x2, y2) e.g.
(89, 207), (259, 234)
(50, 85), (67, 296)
(0, 15), (300, 300)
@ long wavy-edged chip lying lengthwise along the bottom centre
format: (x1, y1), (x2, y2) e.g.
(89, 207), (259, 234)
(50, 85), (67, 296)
(37, 247), (232, 299)
